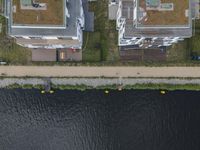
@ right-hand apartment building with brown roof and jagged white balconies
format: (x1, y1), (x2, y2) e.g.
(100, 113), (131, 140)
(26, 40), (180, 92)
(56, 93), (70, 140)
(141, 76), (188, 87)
(109, 0), (199, 48)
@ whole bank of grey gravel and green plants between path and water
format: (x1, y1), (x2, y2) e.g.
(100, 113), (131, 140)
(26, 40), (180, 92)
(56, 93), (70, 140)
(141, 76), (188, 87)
(0, 78), (200, 90)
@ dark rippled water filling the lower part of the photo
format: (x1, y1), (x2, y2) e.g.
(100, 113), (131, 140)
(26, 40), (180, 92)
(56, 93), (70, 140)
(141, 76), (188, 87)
(0, 90), (200, 150)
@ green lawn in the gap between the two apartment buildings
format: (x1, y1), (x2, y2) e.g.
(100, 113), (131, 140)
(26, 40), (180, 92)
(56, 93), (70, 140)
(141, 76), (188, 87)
(83, 0), (119, 62)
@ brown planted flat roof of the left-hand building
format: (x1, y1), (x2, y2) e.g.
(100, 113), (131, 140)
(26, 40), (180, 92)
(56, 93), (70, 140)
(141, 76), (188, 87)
(12, 0), (65, 26)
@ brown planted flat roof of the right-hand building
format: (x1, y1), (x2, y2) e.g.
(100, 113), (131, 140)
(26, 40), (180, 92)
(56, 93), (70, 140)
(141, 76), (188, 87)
(137, 0), (190, 27)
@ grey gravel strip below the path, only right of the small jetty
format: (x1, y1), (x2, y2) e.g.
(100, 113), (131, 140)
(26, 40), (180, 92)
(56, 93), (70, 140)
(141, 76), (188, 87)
(51, 78), (200, 87)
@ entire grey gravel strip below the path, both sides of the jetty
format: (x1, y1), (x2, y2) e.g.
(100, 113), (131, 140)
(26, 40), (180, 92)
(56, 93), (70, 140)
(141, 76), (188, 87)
(0, 78), (200, 88)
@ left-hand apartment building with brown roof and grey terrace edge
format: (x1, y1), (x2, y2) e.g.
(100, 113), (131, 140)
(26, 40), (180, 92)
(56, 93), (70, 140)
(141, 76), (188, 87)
(4, 0), (85, 49)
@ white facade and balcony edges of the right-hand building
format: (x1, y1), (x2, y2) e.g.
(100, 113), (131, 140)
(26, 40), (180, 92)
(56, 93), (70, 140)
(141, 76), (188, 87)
(113, 0), (198, 48)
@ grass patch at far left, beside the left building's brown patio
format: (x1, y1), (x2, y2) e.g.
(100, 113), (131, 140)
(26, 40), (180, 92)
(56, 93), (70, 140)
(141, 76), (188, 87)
(0, 16), (31, 65)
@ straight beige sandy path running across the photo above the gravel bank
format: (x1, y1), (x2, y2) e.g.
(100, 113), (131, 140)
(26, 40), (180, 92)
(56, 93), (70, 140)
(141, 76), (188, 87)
(0, 66), (200, 78)
